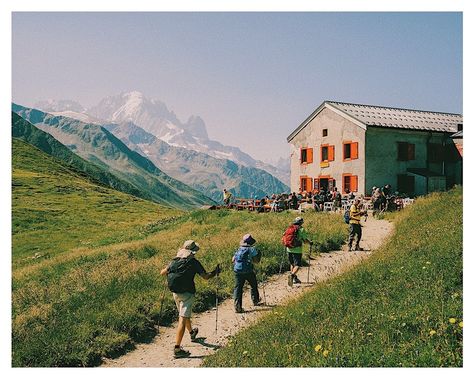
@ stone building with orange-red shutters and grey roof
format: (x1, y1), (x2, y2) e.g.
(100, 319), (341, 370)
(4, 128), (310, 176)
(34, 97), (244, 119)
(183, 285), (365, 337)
(287, 101), (463, 196)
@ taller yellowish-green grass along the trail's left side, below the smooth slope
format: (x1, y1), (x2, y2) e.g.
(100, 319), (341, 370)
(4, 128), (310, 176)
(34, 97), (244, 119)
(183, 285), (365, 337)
(12, 186), (346, 366)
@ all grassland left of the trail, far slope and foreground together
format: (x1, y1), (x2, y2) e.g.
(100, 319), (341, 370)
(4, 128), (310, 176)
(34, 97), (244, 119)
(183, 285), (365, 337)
(12, 139), (346, 367)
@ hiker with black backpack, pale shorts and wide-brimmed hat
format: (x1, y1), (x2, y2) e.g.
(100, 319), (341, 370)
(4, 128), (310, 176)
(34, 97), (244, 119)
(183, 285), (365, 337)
(160, 240), (221, 358)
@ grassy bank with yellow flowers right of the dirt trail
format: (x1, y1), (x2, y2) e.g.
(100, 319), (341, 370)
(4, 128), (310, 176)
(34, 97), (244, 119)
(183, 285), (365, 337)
(205, 188), (463, 367)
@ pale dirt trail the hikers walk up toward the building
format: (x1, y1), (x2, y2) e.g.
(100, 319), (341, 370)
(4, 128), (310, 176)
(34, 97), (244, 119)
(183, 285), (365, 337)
(102, 217), (392, 367)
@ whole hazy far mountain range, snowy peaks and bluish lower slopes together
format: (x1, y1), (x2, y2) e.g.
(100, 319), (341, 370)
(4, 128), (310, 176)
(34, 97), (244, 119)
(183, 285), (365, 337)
(30, 91), (289, 201)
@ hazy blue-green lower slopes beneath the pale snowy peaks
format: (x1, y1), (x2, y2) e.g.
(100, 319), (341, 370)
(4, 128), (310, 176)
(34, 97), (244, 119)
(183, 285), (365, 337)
(104, 122), (290, 202)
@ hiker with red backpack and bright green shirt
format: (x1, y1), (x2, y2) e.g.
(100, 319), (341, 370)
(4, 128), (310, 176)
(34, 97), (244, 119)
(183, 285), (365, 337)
(282, 217), (313, 286)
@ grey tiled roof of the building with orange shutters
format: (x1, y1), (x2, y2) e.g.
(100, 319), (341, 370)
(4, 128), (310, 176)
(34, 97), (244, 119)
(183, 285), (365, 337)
(287, 101), (463, 142)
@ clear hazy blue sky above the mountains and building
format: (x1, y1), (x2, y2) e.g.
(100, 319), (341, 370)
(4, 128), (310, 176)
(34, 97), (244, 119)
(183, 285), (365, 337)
(12, 12), (462, 163)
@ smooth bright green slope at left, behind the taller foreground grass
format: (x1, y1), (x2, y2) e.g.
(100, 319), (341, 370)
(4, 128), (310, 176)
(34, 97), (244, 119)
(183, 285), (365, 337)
(12, 138), (181, 268)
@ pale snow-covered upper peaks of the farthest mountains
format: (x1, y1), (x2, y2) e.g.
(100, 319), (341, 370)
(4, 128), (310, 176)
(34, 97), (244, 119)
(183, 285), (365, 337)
(32, 91), (289, 185)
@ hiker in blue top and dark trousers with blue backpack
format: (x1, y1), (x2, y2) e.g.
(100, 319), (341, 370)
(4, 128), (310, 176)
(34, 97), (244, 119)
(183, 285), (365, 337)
(232, 234), (261, 313)
